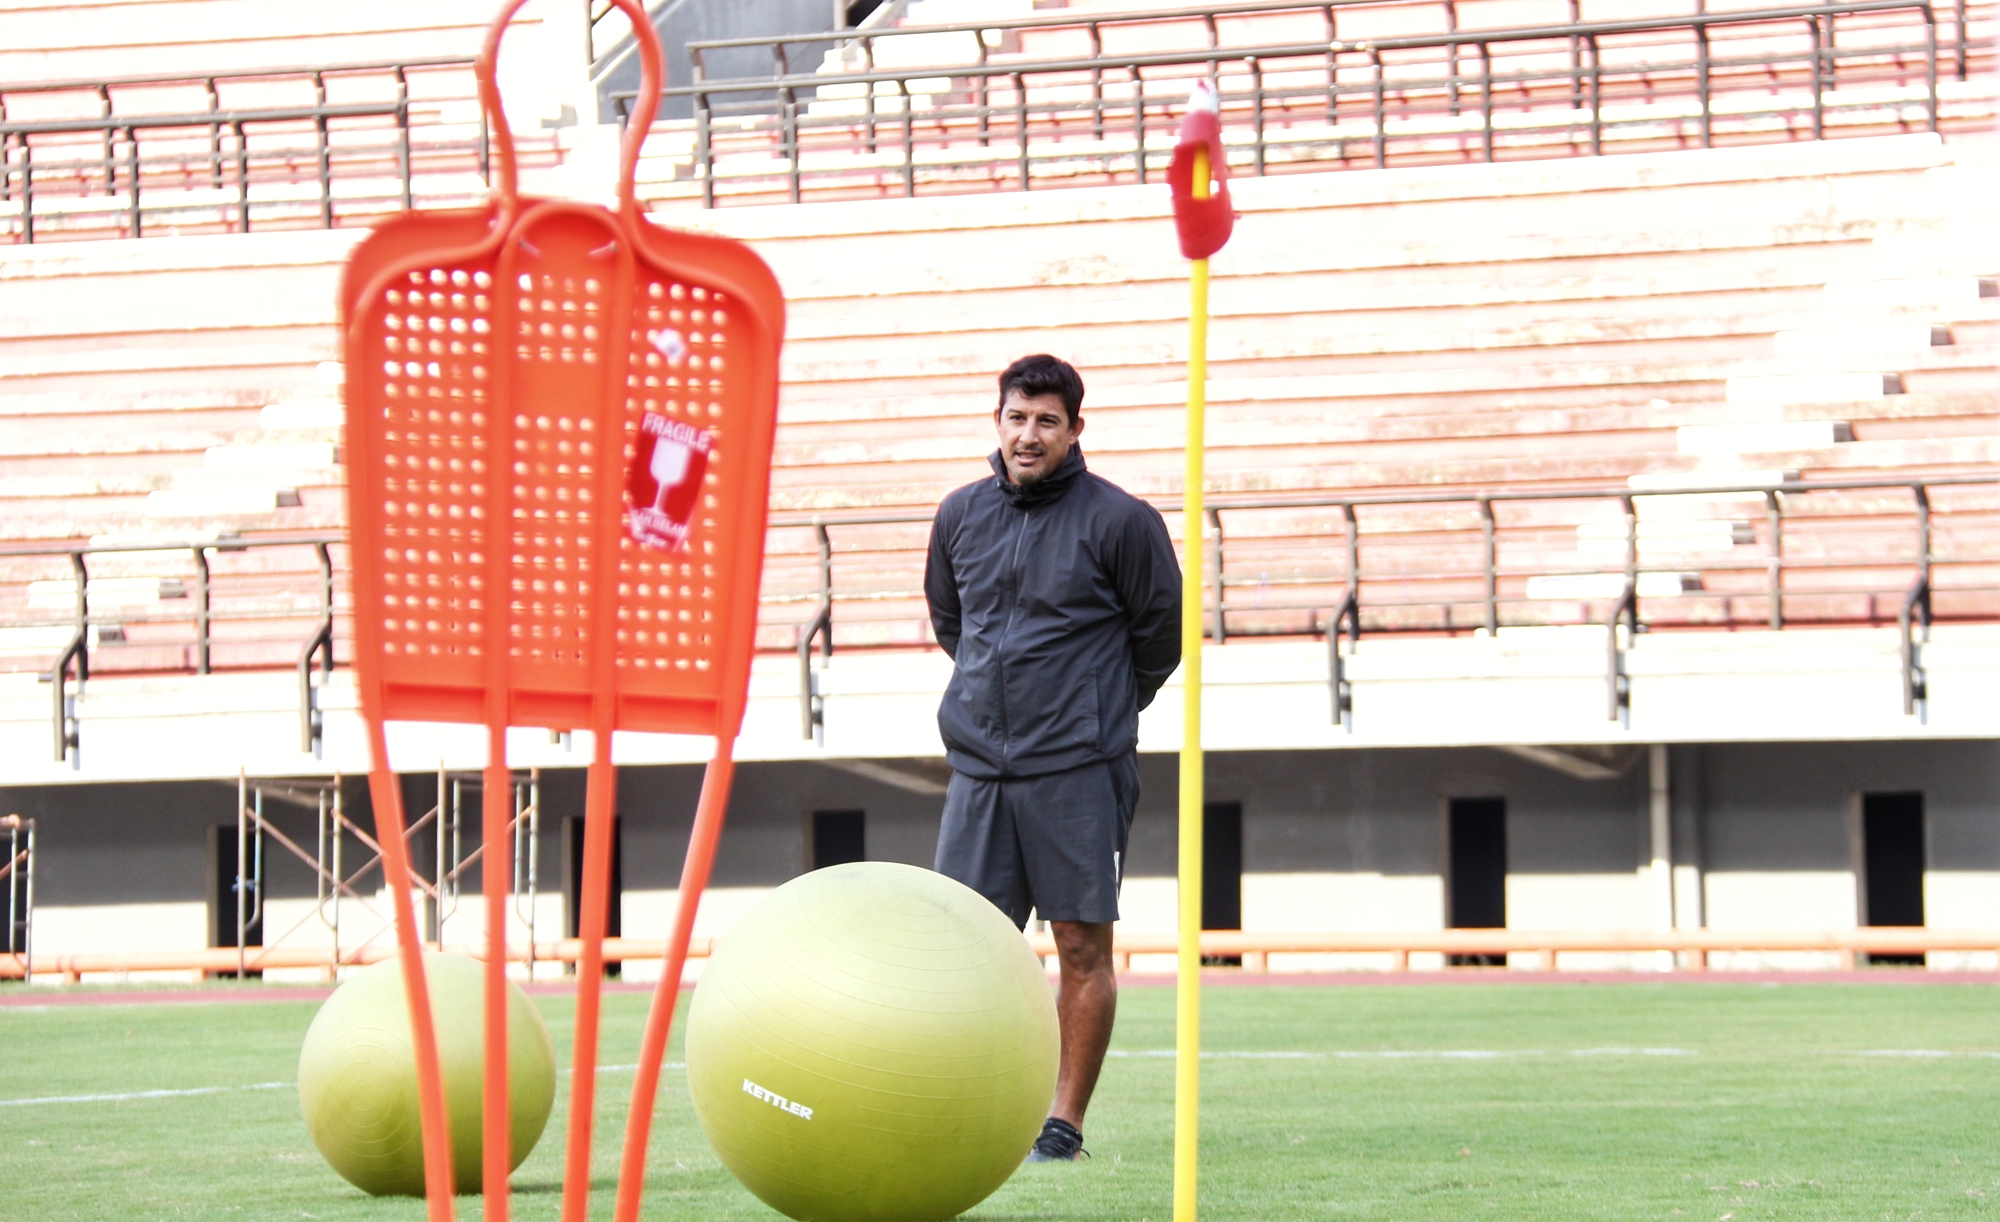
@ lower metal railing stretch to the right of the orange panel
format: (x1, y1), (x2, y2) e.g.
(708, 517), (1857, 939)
(766, 474), (2000, 738)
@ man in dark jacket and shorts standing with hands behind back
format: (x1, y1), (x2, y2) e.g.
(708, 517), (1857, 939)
(924, 356), (1180, 1162)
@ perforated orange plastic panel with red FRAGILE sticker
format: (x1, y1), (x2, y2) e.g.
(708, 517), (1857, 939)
(346, 200), (782, 734)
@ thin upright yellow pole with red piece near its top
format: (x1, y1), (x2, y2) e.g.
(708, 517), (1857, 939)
(1174, 148), (1222, 1222)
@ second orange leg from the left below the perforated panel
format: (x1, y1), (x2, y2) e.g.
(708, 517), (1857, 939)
(480, 726), (514, 1222)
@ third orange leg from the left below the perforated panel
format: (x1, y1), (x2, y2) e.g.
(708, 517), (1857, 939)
(562, 726), (618, 1222)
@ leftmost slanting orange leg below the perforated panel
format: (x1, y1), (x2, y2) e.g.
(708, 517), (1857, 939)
(368, 720), (456, 1222)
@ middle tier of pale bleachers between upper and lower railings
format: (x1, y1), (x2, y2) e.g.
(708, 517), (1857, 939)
(0, 136), (2000, 664)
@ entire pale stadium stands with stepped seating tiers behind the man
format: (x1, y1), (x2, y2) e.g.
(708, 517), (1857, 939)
(0, 0), (2000, 980)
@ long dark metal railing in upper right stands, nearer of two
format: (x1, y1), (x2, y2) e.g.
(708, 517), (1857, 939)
(640, 0), (1962, 206)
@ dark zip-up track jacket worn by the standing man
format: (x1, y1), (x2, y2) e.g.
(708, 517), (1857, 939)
(924, 450), (1180, 780)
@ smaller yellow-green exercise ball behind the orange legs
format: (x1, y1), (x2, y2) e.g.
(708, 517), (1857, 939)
(298, 952), (556, 1196)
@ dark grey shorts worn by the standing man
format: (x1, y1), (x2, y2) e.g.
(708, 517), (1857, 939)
(938, 752), (1138, 926)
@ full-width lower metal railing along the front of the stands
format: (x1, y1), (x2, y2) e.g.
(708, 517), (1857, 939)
(0, 474), (2000, 760)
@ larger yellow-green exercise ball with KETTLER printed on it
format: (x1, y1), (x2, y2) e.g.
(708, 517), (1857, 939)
(686, 862), (1058, 1222)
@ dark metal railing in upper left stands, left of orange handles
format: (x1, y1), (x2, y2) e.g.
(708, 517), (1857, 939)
(0, 58), (490, 242)
